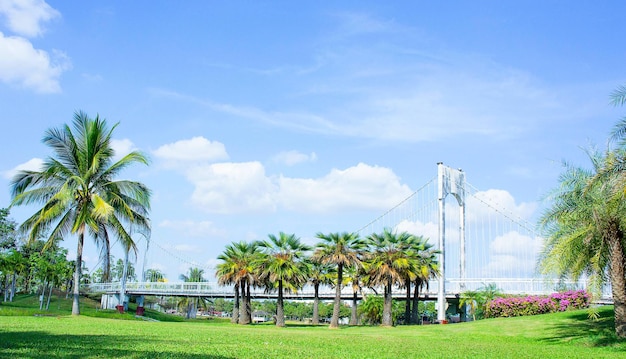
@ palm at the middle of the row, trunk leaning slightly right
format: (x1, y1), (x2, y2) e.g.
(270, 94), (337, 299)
(312, 232), (365, 328)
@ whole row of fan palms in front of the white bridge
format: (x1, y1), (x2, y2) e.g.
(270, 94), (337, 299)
(216, 229), (439, 328)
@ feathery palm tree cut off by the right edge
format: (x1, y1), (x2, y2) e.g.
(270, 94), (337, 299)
(540, 149), (626, 337)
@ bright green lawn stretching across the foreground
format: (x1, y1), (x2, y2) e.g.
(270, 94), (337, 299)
(0, 296), (626, 359)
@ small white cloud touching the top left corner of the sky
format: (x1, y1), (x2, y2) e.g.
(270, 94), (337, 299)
(0, 0), (61, 37)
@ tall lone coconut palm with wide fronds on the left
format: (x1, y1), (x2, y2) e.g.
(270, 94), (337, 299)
(11, 112), (150, 315)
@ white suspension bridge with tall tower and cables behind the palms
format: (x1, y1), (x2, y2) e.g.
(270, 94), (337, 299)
(85, 163), (611, 320)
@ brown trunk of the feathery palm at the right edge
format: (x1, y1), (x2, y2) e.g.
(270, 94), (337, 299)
(608, 228), (626, 338)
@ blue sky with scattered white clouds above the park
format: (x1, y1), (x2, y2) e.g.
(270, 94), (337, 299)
(0, 0), (626, 280)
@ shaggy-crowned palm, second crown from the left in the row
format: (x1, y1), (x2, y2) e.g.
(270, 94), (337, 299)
(258, 232), (311, 327)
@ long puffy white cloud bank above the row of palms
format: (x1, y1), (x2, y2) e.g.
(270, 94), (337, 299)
(174, 162), (412, 217)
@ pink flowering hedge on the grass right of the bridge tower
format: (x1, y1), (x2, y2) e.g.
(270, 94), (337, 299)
(485, 290), (591, 318)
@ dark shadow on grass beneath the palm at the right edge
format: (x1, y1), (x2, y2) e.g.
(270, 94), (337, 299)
(544, 309), (626, 351)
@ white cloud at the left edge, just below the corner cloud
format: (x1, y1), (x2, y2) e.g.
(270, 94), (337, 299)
(0, 32), (71, 93)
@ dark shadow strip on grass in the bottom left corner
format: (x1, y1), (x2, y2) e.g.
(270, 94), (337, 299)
(0, 331), (232, 359)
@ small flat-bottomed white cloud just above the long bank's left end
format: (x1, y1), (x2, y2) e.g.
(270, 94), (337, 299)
(154, 136), (228, 162)
